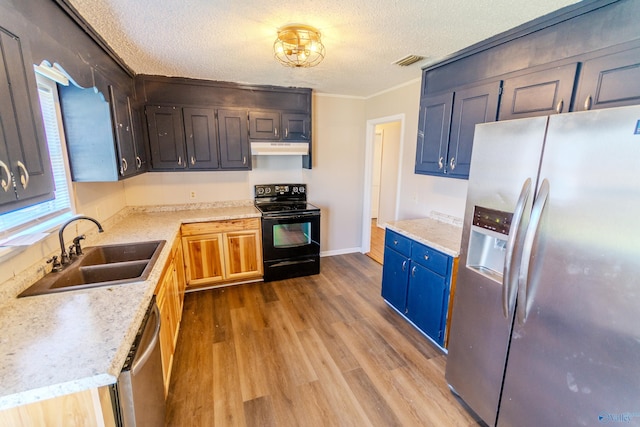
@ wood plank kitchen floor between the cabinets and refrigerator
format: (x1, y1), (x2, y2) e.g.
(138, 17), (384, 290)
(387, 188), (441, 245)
(167, 254), (482, 427)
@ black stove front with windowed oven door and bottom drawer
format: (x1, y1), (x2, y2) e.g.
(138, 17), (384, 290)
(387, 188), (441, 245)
(262, 212), (320, 281)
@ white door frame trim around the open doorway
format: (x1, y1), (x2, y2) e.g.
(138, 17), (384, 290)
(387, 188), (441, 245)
(360, 114), (405, 254)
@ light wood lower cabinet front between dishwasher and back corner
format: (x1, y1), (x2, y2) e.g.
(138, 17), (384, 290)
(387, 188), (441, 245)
(156, 237), (186, 397)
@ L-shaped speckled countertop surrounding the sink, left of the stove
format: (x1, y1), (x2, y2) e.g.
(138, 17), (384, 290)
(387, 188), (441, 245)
(0, 201), (260, 410)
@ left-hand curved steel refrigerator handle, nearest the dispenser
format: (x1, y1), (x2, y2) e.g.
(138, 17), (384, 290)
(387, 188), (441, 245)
(502, 178), (531, 319)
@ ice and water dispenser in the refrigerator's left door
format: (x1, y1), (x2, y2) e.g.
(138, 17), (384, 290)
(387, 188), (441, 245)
(467, 206), (513, 283)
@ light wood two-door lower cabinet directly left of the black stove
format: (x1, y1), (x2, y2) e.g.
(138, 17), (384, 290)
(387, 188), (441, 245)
(182, 218), (263, 287)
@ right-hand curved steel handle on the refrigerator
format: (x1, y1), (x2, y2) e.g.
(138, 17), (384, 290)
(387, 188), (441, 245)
(517, 178), (549, 325)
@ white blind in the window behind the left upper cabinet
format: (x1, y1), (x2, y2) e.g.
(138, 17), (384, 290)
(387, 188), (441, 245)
(0, 74), (71, 240)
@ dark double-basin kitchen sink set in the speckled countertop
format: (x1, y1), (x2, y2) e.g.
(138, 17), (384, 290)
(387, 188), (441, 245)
(18, 240), (166, 297)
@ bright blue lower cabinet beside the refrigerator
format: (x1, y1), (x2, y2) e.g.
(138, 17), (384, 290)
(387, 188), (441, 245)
(382, 229), (453, 348)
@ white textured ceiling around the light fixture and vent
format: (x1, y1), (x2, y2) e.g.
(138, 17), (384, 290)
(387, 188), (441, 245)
(70, 0), (575, 97)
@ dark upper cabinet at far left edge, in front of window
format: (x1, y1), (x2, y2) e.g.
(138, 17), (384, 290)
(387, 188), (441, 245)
(0, 22), (54, 213)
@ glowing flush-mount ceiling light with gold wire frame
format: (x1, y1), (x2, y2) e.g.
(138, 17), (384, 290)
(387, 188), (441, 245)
(273, 24), (324, 68)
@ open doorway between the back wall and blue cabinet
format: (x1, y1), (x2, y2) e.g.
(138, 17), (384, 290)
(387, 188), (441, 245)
(362, 115), (404, 264)
